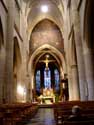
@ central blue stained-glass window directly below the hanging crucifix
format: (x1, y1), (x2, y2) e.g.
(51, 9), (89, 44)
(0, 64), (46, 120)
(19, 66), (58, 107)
(44, 68), (51, 88)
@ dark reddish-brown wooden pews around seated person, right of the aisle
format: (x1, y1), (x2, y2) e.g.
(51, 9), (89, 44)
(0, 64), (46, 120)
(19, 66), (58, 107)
(53, 101), (94, 124)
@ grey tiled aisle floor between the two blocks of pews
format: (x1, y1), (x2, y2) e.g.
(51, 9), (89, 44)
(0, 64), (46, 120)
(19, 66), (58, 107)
(26, 108), (55, 125)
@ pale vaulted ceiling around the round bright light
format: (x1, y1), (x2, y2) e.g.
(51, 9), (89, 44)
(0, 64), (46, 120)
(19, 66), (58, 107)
(24, 0), (64, 35)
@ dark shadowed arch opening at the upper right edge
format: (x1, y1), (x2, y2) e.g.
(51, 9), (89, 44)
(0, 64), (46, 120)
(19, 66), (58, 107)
(84, 0), (94, 50)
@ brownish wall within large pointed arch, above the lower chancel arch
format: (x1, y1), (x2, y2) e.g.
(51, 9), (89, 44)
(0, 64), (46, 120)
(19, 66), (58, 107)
(29, 18), (64, 53)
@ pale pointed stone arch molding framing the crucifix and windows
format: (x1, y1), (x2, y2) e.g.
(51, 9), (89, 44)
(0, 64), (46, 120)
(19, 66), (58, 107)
(28, 44), (66, 75)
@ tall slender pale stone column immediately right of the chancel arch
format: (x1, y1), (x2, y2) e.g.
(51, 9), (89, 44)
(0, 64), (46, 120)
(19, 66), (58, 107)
(64, 8), (73, 101)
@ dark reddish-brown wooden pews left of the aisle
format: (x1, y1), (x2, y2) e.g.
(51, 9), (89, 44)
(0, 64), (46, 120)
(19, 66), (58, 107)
(0, 103), (38, 125)
